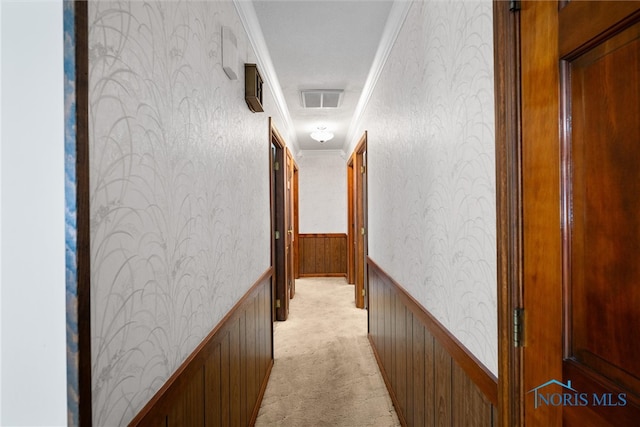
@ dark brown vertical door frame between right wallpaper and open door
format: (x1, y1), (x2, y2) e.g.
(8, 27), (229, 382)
(493, 0), (524, 427)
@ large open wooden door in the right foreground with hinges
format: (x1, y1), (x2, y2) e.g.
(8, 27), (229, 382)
(521, 1), (640, 426)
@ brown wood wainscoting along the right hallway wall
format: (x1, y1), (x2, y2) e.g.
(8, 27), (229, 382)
(367, 259), (498, 427)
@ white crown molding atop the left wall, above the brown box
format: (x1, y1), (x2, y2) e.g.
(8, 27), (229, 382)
(233, 0), (300, 157)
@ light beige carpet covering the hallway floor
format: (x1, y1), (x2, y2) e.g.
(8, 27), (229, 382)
(256, 278), (400, 427)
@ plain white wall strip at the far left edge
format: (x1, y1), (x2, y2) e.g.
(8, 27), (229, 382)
(0, 0), (67, 426)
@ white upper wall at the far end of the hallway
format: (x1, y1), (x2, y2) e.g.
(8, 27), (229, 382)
(296, 151), (347, 233)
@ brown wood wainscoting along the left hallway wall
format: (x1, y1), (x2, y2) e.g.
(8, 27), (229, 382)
(129, 268), (273, 427)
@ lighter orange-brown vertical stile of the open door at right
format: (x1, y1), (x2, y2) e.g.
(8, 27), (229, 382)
(520, 1), (564, 425)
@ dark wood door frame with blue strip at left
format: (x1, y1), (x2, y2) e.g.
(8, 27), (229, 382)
(63, 1), (93, 425)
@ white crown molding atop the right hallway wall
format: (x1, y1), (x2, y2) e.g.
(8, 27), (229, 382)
(342, 0), (413, 157)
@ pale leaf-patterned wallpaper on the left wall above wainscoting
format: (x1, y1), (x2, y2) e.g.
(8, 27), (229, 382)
(89, 1), (282, 426)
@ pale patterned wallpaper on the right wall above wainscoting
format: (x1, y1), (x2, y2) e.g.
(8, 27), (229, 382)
(358, 0), (498, 376)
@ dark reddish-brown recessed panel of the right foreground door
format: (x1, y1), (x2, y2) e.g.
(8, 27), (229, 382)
(569, 20), (640, 391)
